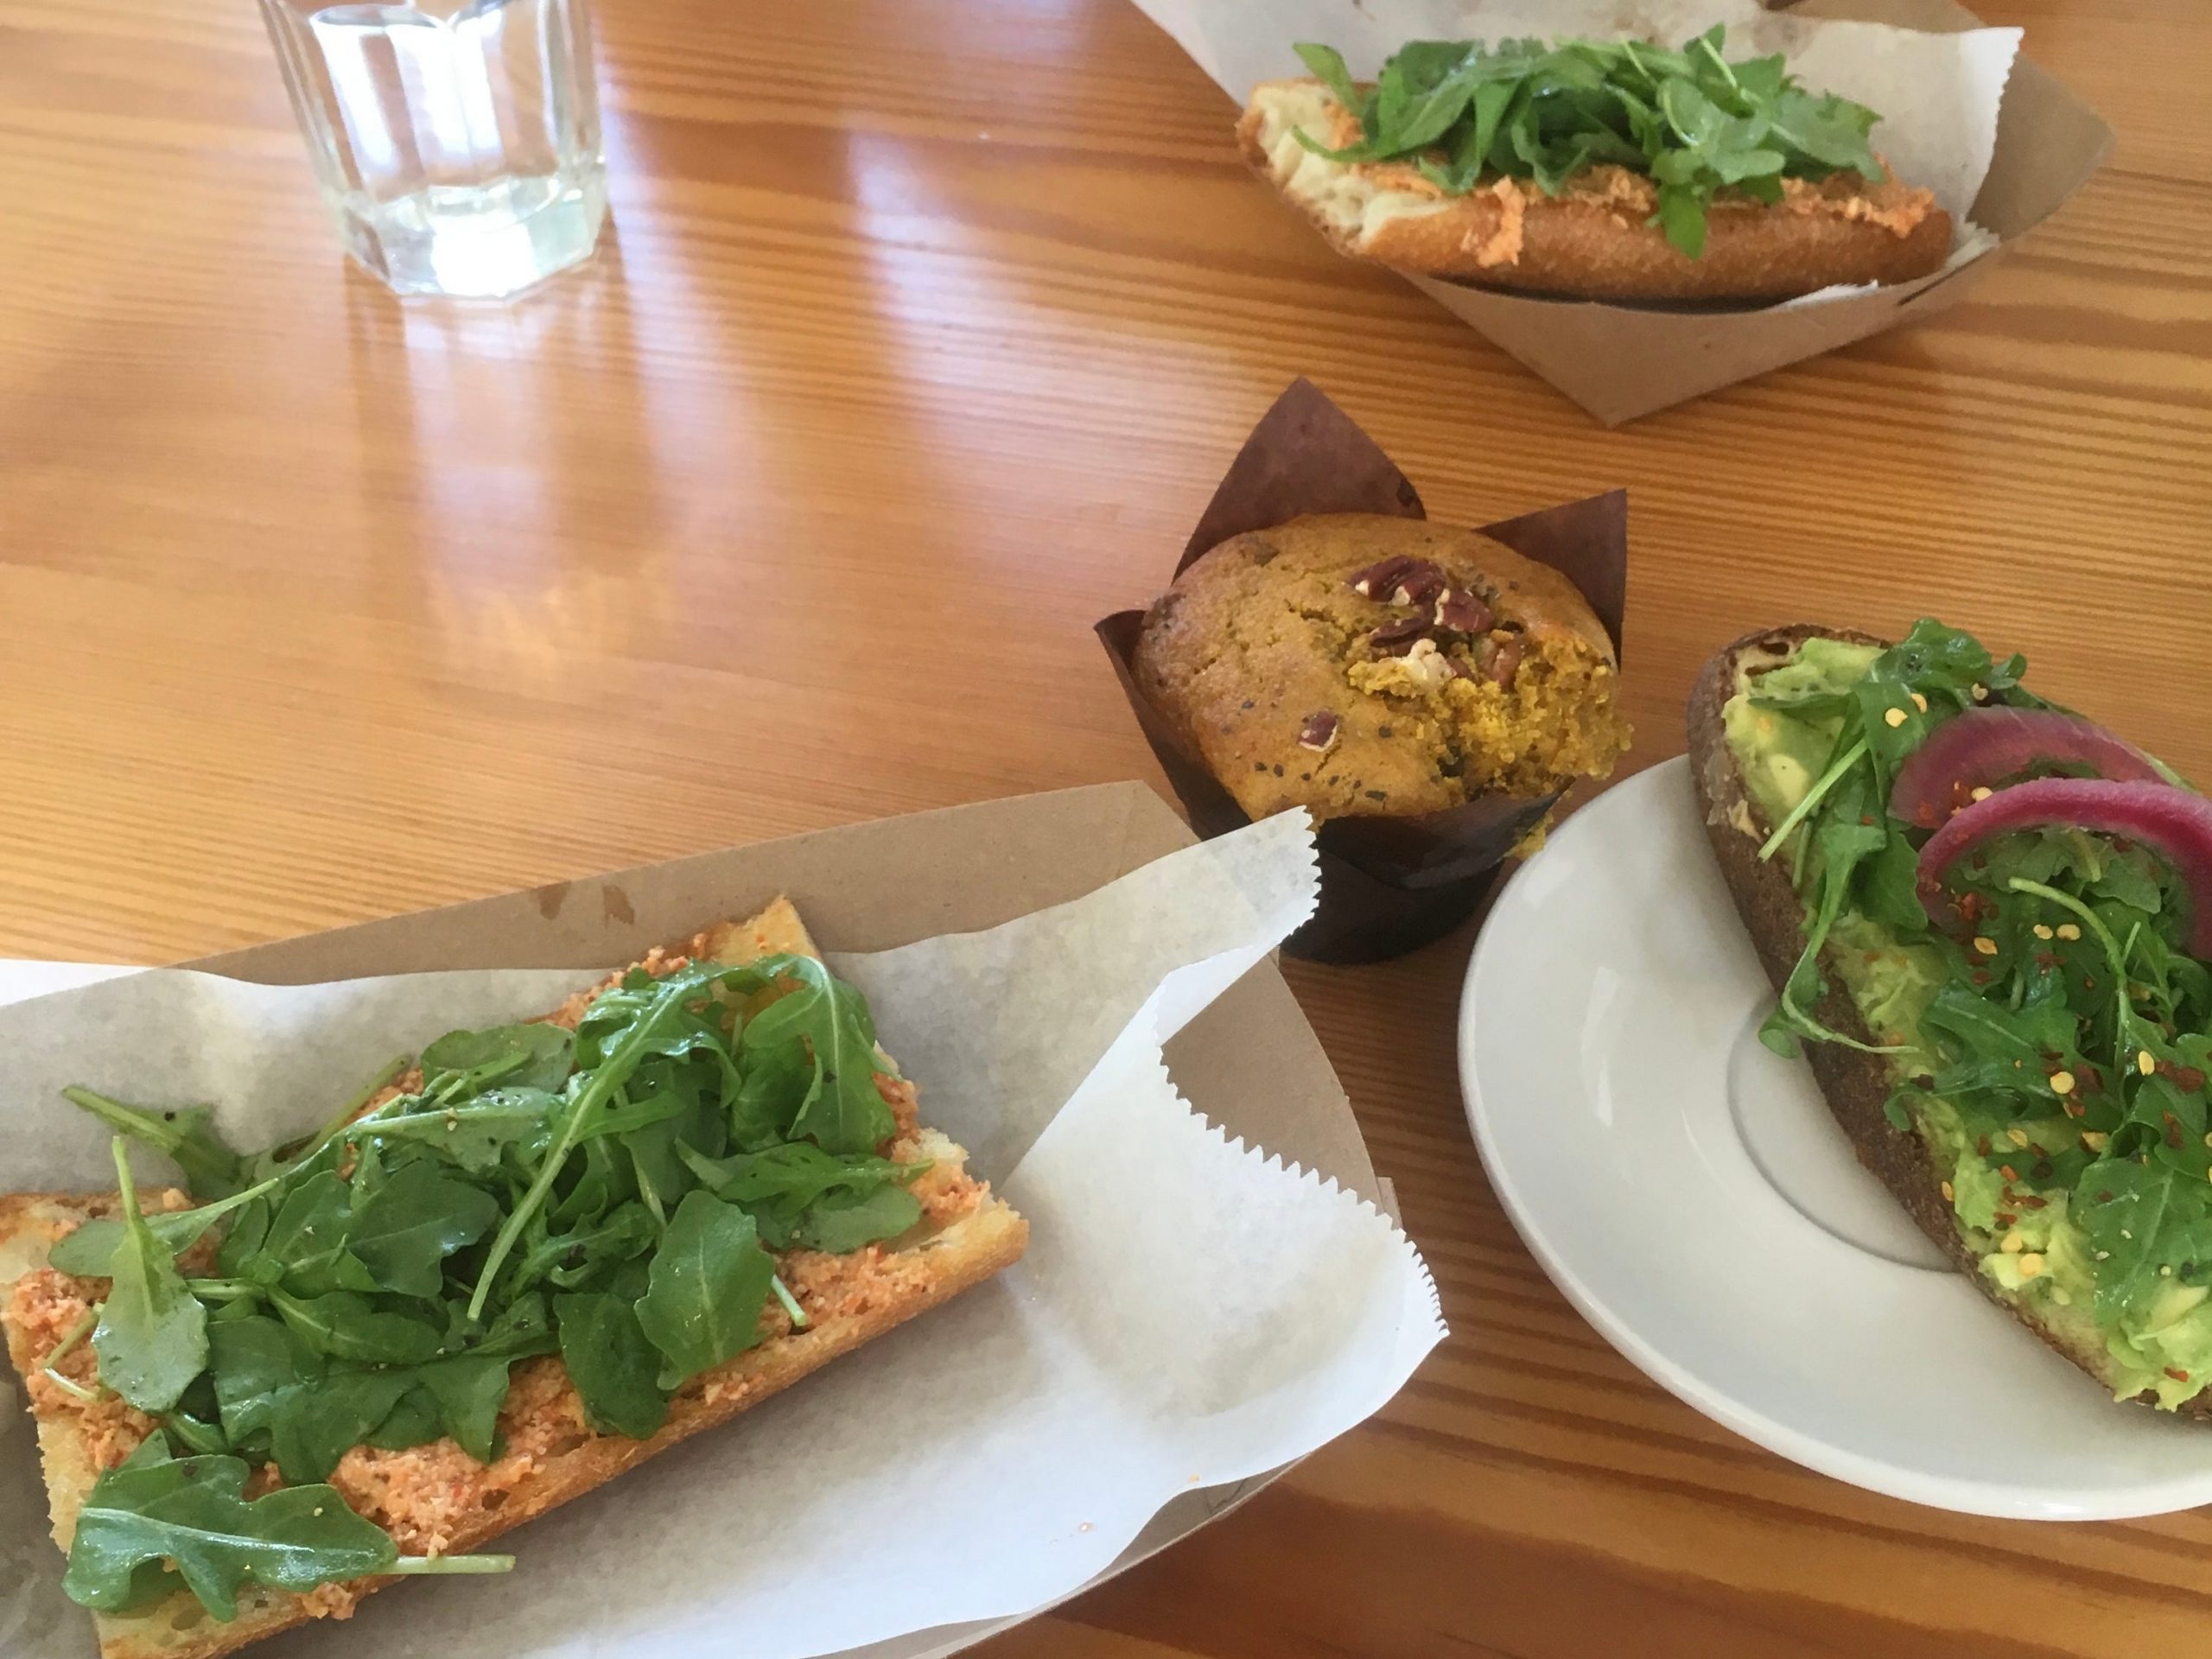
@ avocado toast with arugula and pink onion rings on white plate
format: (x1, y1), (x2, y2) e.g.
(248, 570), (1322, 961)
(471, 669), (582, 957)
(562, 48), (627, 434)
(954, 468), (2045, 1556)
(1690, 621), (2212, 1418)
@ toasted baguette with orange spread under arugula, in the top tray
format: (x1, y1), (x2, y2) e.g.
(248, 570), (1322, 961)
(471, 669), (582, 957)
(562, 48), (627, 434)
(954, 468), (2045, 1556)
(1236, 79), (1951, 301)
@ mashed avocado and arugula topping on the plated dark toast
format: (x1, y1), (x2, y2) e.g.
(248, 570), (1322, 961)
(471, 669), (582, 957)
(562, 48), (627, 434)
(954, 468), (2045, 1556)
(1723, 621), (2212, 1409)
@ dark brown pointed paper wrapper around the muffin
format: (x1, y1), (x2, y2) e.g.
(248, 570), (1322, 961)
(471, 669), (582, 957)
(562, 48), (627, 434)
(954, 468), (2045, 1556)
(1097, 380), (1628, 963)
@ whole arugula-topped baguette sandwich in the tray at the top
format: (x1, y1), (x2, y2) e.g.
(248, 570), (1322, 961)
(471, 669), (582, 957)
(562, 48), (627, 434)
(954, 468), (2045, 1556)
(1236, 24), (1951, 301)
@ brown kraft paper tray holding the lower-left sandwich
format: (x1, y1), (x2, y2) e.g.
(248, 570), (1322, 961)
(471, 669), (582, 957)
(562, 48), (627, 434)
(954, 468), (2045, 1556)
(35, 783), (1389, 1659)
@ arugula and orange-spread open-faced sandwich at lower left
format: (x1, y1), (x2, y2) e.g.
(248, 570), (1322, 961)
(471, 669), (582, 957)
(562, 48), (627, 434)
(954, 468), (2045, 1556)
(0, 900), (1028, 1659)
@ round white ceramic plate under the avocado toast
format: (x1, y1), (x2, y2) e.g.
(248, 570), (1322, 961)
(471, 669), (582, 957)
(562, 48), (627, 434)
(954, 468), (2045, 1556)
(1460, 761), (2212, 1520)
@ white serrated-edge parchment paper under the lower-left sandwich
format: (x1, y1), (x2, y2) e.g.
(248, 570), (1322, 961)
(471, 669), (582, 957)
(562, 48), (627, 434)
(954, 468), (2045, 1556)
(0, 814), (1445, 1659)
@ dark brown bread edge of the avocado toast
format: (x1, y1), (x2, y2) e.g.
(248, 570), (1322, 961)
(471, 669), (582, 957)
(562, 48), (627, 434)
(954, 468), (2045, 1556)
(1690, 621), (2177, 1418)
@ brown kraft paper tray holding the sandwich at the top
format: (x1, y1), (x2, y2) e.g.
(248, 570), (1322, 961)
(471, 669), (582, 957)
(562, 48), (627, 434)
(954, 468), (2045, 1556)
(1137, 0), (2113, 427)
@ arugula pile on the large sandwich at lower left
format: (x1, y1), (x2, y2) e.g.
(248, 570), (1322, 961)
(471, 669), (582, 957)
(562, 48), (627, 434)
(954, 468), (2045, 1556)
(47, 956), (927, 1619)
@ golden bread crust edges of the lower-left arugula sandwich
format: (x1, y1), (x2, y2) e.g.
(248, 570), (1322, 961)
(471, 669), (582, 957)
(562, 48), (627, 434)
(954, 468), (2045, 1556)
(0, 898), (1028, 1659)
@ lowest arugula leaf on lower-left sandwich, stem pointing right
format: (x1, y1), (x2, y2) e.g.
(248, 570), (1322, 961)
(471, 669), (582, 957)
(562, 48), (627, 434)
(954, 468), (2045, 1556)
(62, 1435), (515, 1621)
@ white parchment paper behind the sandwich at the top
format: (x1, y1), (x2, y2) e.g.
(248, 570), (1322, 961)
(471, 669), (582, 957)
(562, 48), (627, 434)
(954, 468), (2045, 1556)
(1137, 0), (2022, 305)
